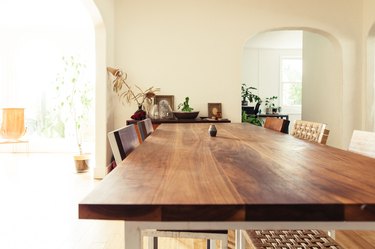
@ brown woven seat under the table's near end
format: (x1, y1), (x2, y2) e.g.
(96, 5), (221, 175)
(245, 230), (343, 249)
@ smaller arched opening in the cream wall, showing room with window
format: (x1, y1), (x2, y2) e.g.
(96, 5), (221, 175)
(242, 28), (342, 147)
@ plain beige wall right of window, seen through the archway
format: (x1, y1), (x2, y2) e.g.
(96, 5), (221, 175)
(302, 32), (342, 148)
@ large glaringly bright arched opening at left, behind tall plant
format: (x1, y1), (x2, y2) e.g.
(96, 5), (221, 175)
(0, 0), (105, 175)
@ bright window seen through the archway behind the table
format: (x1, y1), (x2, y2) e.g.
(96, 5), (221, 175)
(280, 57), (302, 110)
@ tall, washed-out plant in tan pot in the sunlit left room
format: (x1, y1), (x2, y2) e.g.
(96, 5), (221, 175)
(55, 56), (93, 173)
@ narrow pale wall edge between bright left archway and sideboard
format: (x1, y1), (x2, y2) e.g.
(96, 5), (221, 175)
(90, 0), (115, 178)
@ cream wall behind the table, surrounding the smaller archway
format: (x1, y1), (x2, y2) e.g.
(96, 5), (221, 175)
(96, 0), (363, 158)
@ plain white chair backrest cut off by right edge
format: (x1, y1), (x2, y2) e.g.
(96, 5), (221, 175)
(348, 130), (375, 158)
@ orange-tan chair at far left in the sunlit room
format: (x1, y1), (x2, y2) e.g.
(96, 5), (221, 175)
(0, 108), (26, 140)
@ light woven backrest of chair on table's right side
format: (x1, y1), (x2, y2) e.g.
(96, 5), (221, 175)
(290, 120), (329, 144)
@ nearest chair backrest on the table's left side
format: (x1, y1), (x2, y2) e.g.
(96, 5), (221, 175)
(108, 124), (139, 165)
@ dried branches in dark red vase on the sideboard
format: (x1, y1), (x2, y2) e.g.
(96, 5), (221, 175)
(107, 67), (160, 120)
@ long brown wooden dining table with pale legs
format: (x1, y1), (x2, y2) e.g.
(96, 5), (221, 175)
(79, 123), (375, 249)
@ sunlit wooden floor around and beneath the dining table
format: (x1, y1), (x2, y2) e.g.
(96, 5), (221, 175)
(0, 153), (375, 249)
